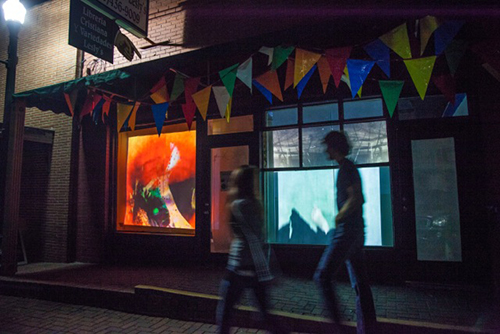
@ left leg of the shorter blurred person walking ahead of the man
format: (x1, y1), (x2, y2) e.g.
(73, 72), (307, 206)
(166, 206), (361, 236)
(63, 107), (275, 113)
(216, 275), (243, 334)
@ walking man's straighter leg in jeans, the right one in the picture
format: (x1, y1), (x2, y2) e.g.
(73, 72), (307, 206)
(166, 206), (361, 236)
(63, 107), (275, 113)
(346, 236), (377, 334)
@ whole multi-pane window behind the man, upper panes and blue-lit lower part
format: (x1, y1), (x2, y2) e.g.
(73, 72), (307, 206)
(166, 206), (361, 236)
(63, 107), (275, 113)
(262, 98), (393, 246)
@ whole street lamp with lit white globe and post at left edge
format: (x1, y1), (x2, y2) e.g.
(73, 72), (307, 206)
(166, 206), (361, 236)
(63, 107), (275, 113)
(0, 0), (26, 275)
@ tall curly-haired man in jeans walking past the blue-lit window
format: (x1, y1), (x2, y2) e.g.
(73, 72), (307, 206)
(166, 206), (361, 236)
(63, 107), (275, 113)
(314, 131), (377, 334)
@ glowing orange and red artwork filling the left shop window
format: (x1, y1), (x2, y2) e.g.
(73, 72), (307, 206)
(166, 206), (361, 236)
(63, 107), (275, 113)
(124, 131), (196, 229)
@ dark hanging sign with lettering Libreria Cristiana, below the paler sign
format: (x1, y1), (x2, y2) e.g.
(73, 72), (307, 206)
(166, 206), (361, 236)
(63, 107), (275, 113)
(68, 0), (118, 63)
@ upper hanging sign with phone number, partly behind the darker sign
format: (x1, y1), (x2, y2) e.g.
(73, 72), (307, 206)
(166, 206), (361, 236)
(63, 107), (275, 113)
(82, 0), (149, 38)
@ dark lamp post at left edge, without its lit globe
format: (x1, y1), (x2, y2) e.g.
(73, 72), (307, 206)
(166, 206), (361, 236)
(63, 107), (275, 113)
(0, 22), (24, 275)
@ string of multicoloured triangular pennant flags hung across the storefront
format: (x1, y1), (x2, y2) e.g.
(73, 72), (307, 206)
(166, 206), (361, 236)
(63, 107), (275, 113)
(61, 16), (492, 135)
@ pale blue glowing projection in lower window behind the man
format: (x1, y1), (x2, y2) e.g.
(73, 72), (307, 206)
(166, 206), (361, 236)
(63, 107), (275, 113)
(265, 167), (393, 246)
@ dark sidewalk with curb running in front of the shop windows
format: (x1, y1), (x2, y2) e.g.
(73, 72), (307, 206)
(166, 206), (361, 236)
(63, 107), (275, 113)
(0, 263), (500, 333)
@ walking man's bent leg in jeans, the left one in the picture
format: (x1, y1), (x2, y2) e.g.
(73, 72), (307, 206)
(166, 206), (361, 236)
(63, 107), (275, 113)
(314, 227), (351, 325)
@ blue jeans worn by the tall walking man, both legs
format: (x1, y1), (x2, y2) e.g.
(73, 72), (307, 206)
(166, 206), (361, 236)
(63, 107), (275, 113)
(314, 223), (377, 334)
